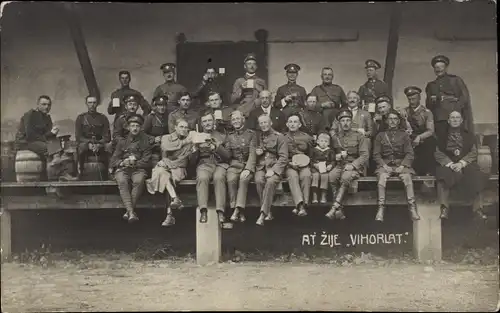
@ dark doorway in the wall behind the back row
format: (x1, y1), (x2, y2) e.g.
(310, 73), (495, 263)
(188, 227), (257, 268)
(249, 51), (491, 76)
(177, 41), (268, 105)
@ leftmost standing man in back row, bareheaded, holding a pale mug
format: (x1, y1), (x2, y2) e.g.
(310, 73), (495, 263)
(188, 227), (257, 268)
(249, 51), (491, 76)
(108, 71), (151, 122)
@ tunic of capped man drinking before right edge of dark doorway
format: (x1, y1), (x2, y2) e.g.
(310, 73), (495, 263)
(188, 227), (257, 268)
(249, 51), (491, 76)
(231, 73), (267, 117)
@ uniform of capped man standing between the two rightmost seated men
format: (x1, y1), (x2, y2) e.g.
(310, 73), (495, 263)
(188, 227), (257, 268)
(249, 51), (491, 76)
(404, 105), (436, 176)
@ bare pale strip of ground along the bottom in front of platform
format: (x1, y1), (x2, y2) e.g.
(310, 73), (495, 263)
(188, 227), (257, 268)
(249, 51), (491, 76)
(2, 259), (498, 312)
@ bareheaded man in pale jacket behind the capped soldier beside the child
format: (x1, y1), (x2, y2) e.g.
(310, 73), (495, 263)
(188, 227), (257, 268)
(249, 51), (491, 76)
(330, 91), (374, 138)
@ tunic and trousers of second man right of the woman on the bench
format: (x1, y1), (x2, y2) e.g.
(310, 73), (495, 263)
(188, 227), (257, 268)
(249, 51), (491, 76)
(226, 128), (257, 208)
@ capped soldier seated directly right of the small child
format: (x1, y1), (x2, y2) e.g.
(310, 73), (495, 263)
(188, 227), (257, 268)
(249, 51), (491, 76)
(326, 109), (370, 219)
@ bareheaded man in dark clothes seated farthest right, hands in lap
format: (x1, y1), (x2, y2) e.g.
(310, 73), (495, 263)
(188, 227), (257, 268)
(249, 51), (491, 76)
(435, 111), (489, 219)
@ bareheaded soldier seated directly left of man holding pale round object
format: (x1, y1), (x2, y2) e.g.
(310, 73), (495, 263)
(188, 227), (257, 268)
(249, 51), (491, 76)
(255, 114), (288, 226)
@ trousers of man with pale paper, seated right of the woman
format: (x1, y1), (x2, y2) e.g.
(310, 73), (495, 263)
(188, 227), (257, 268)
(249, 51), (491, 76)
(196, 163), (226, 211)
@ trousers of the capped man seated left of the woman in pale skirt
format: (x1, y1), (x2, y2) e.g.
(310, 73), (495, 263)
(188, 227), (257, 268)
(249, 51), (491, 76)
(115, 168), (146, 212)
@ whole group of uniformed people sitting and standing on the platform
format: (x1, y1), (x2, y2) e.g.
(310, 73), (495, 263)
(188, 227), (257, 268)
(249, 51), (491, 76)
(16, 54), (485, 226)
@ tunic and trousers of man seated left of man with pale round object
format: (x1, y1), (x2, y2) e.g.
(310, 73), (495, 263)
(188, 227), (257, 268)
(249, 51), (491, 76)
(255, 129), (288, 215)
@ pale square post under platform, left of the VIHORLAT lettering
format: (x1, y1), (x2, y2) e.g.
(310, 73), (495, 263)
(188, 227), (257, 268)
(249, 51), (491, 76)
(196, 207), (222, 265)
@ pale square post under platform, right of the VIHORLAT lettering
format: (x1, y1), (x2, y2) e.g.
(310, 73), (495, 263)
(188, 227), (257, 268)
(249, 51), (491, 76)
(413, 201), (442, 261)
